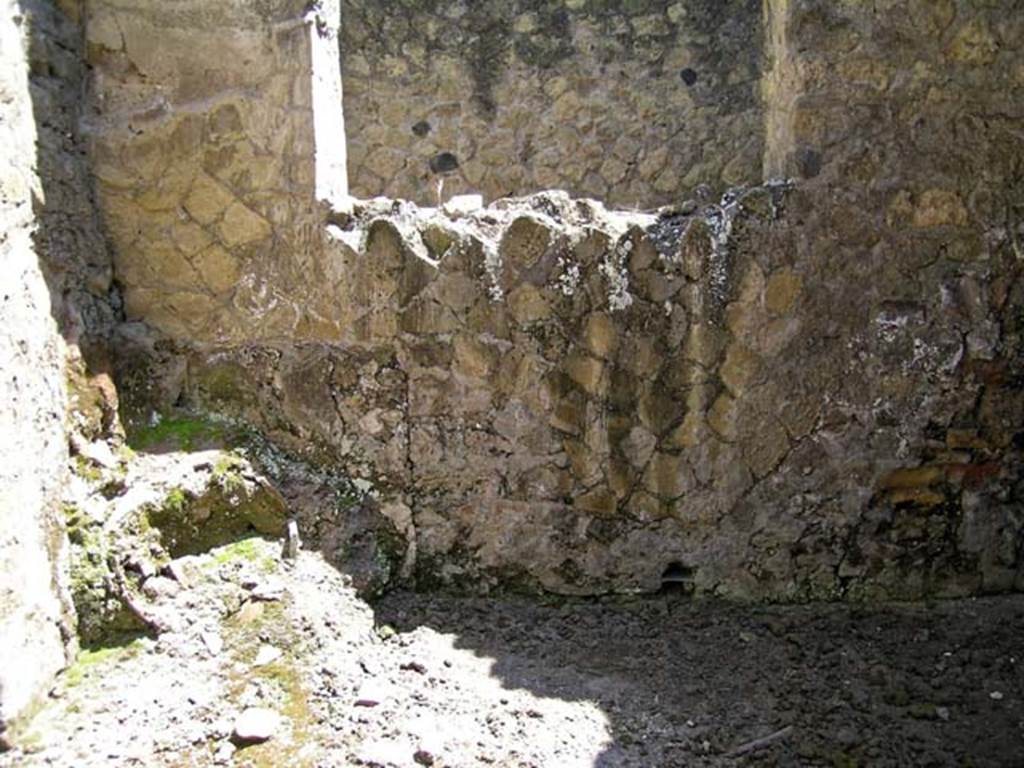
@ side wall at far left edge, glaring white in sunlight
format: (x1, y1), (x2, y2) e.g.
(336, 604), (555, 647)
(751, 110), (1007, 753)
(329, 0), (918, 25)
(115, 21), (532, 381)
(0, 0), (89, 740)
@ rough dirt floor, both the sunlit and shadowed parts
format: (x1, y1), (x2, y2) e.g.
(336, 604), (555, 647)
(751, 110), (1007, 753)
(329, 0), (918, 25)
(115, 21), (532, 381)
(0, 539), (1024, 768)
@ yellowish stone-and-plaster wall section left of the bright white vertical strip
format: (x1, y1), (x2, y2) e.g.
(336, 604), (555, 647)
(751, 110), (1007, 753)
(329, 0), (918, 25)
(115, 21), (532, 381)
(86, 0), (339, 339)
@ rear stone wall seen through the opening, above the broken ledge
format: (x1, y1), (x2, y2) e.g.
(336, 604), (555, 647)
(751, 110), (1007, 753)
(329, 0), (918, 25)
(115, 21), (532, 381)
(341, 0), (763, 207)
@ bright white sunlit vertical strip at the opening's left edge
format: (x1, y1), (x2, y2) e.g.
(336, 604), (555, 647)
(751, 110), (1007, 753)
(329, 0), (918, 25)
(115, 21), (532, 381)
(307, 0), (348, 206)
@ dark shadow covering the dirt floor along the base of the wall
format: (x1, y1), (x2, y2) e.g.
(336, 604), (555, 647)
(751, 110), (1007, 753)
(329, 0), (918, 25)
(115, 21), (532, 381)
(375, 593), (1024, 768)
